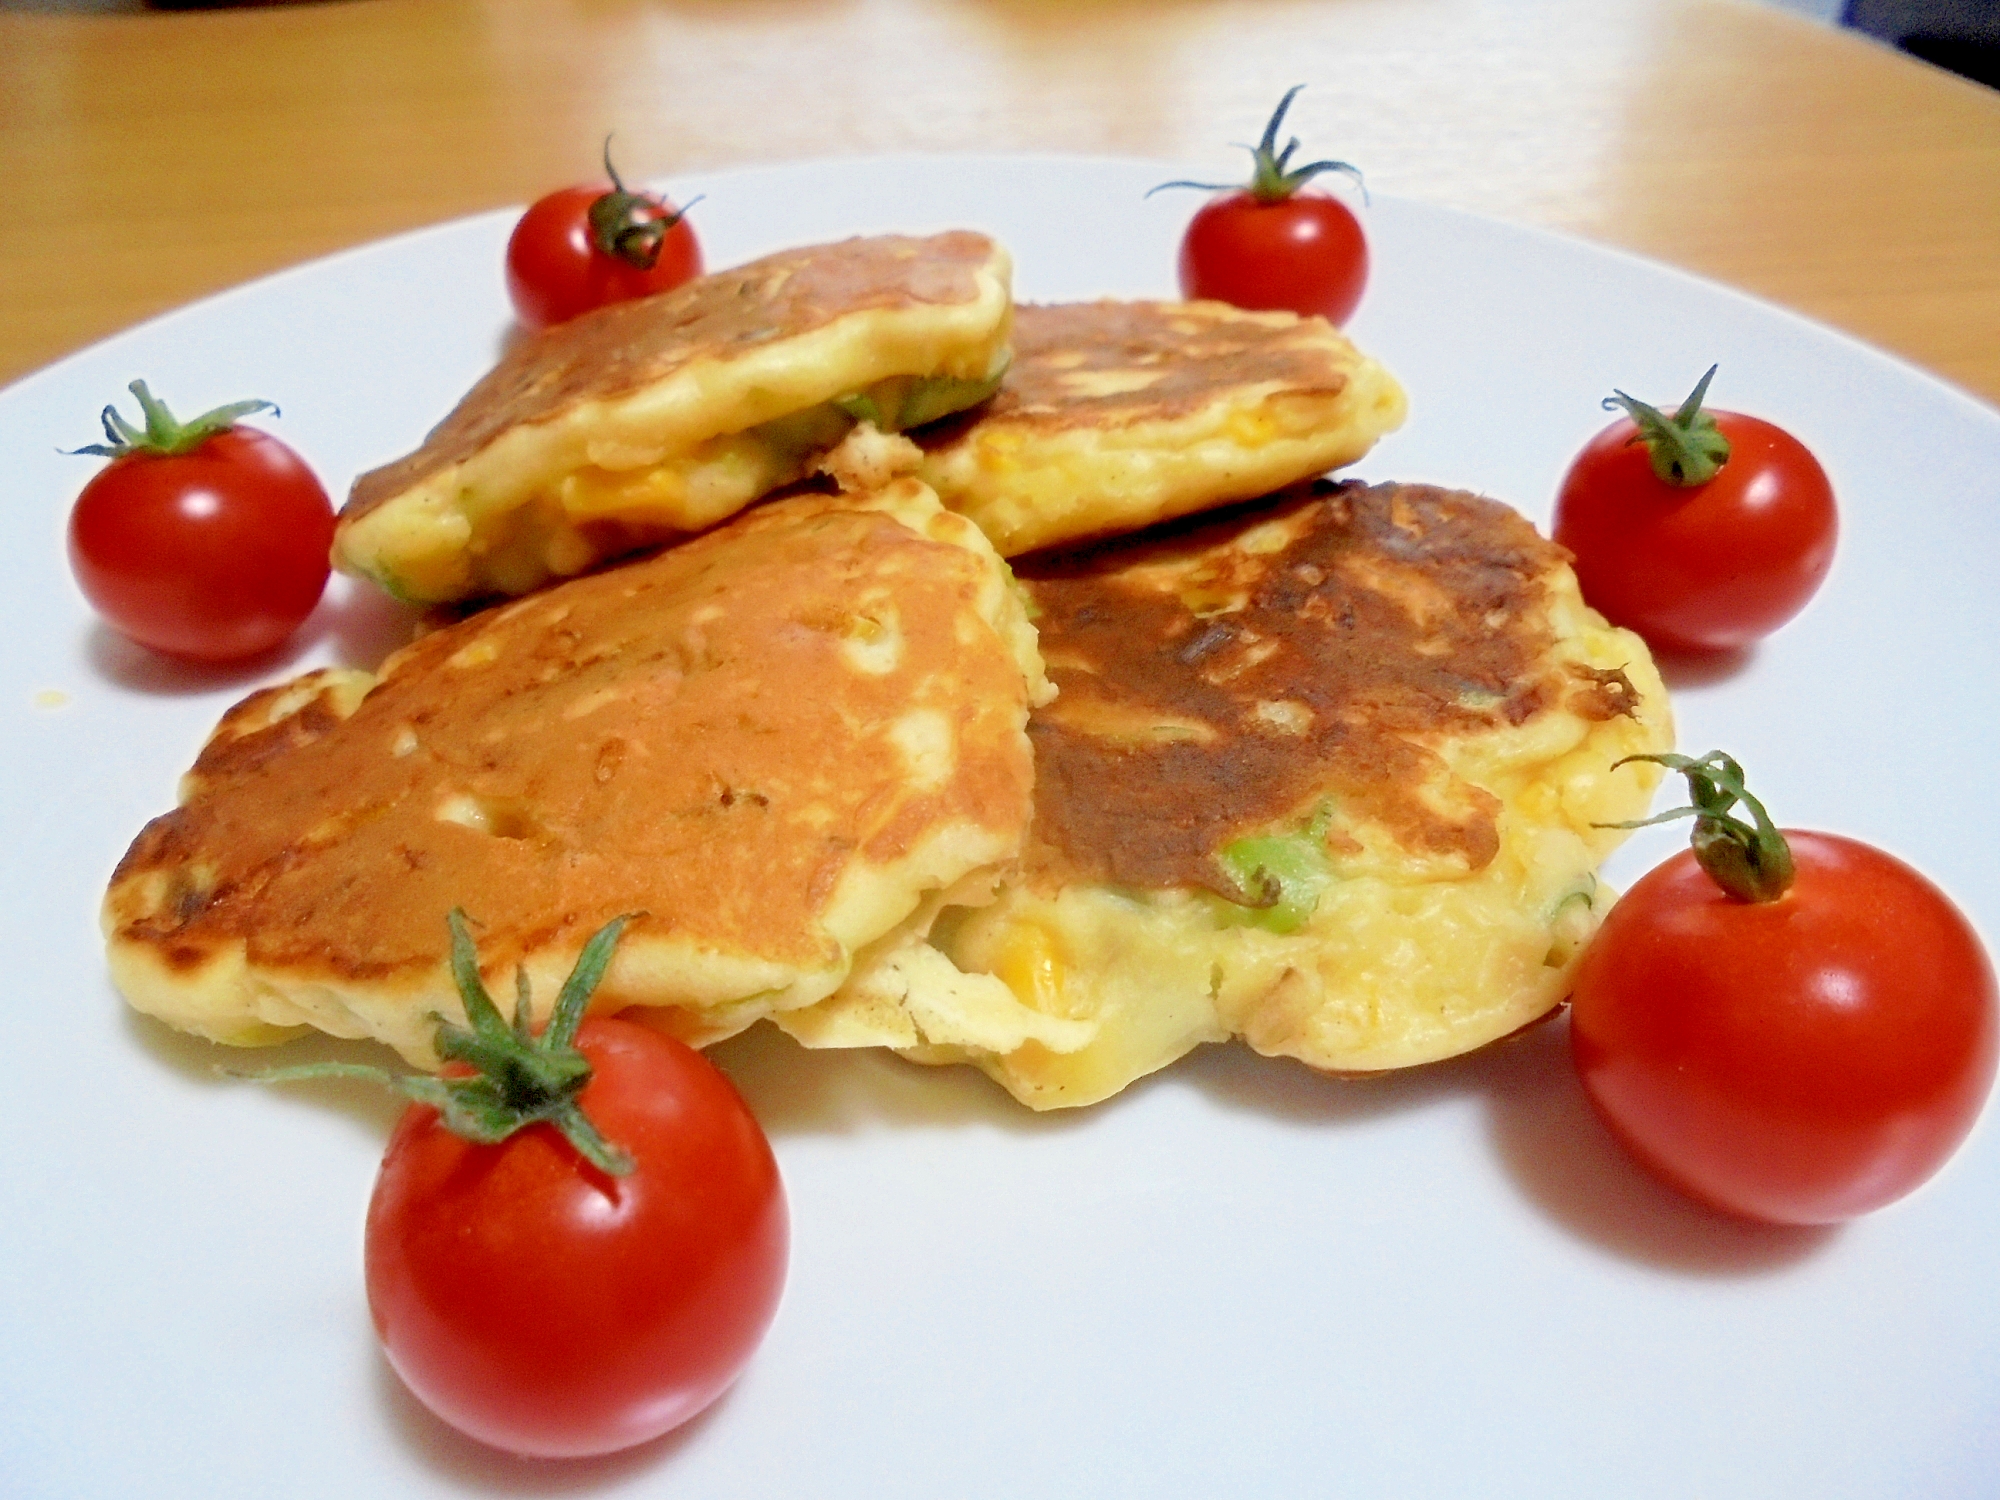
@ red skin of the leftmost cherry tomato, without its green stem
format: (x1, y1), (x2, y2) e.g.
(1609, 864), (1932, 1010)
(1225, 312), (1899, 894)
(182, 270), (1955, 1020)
(70, 426), (334, 662)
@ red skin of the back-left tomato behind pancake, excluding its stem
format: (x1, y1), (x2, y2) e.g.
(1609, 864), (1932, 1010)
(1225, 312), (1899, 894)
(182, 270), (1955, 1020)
(506, 182), (702, 328)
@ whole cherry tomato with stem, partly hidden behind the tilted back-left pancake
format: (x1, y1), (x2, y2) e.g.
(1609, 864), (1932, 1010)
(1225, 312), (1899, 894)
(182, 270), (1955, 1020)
(506, 174), (702, 328)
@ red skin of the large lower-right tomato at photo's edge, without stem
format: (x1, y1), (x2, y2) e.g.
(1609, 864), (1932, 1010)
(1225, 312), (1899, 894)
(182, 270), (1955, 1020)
(1570, 832), (2000, 1224)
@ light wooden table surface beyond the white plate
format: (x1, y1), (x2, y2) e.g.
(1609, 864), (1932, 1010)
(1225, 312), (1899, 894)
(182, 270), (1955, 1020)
(0, 0), (2000, 402)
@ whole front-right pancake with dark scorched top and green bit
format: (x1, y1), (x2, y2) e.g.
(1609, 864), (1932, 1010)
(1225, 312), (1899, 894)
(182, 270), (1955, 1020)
(780, 484), (1672, 1108)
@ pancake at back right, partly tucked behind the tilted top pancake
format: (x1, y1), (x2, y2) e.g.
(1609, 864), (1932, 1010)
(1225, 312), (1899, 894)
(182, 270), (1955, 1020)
(920, 302), (1404, 558)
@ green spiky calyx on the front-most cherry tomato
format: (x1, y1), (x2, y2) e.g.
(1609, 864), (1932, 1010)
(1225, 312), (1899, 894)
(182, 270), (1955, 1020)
(242, 906), (632, 1176)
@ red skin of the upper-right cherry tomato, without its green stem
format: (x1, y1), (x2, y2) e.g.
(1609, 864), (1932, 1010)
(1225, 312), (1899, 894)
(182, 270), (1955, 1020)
(1554, 412), (1840, 652)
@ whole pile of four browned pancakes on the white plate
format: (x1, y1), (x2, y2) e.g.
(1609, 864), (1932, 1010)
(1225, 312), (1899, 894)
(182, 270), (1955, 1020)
(106, 232), (1670, 1108)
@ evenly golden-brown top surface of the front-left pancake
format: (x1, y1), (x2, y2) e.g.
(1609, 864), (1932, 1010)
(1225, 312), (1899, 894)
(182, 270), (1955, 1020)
(114, 496), (1032, 982)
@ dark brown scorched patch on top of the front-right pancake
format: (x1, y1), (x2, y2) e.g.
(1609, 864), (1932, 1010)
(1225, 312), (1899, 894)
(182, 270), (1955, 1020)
(1020, 484), (1630, 898)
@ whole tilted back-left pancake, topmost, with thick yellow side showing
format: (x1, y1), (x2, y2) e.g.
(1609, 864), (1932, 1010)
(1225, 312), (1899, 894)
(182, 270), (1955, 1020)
(334, 232), (1012, 602)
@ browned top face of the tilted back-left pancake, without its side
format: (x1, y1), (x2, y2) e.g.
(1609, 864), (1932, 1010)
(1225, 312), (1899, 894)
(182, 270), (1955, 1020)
(342, 230), (994, 522)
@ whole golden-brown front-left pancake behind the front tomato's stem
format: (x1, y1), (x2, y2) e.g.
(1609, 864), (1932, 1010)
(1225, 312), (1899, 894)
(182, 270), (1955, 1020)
(104, 480), (1048, 1066)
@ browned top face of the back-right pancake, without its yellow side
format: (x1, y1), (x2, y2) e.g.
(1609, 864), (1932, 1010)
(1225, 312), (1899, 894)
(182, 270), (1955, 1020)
(920, 302), (1348, 438)
